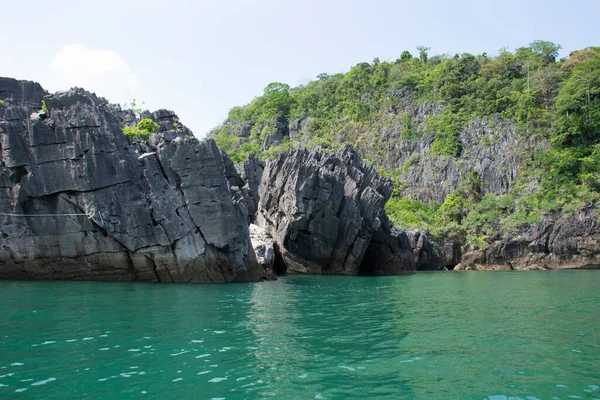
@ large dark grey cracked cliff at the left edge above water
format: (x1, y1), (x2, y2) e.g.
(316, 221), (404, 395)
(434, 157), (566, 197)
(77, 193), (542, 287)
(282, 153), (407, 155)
(0, 81), (263, 282)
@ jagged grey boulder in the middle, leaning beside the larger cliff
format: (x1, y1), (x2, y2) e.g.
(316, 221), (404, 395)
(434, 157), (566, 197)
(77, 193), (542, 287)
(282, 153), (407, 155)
(257, 145), (415, 275)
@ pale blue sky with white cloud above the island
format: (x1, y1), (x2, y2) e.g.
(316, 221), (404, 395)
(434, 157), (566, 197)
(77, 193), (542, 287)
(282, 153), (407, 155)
(0, 0), (600, 137)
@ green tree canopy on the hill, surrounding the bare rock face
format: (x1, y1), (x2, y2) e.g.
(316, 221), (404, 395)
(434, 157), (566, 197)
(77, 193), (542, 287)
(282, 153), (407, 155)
(213, 40), (600, 242)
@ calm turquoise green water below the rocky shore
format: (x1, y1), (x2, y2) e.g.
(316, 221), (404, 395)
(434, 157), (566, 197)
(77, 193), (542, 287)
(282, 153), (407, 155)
(0, 271), (600, 400)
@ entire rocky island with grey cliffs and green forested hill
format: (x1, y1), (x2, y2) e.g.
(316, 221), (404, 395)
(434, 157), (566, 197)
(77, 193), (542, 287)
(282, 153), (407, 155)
(0, 41), (600, 282)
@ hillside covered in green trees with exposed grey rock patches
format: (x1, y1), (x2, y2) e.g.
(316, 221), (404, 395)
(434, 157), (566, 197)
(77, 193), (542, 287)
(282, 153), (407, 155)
(210, 41), (600, 248)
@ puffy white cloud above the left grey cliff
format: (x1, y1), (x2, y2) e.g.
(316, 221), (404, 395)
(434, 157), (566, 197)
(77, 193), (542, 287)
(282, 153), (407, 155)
(49, 44), (142, 103)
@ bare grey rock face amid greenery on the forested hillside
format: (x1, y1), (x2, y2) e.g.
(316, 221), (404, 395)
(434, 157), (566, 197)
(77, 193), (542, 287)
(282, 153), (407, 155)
(338, 89), (548, 202)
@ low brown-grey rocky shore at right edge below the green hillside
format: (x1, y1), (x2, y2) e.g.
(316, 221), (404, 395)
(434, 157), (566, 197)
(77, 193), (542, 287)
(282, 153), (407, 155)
(457, 206), (600, 270)
